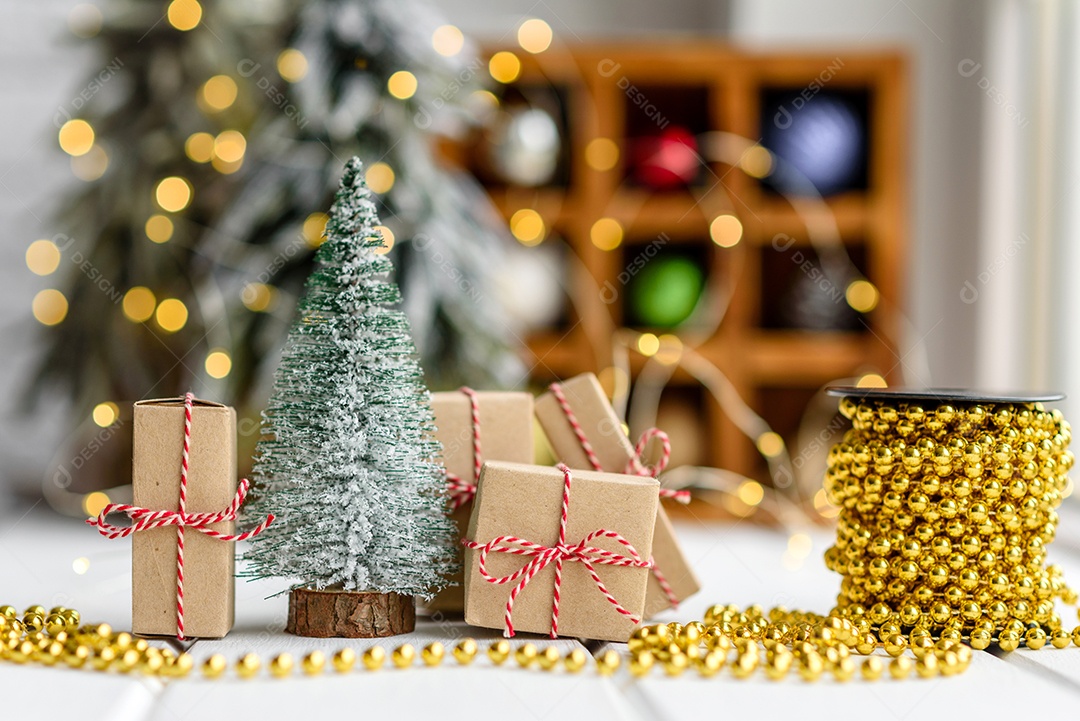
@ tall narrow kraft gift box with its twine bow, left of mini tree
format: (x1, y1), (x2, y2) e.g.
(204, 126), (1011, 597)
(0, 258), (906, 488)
(86, 393), (273, 640)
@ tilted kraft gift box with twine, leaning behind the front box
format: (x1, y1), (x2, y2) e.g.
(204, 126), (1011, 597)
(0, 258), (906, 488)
(536, 373), (701, 618)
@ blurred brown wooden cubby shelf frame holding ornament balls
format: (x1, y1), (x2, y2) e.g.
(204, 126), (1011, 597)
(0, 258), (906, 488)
(470, 40), (908, 476)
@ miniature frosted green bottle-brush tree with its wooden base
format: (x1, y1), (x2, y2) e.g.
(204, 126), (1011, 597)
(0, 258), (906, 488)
(244, 158), (454, 637)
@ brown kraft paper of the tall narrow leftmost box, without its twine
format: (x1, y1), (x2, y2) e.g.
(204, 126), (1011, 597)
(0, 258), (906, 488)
(131, 398), (238, 638)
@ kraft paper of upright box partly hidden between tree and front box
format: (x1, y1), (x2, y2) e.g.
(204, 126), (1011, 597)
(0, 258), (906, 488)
(424, 391), (535, 613)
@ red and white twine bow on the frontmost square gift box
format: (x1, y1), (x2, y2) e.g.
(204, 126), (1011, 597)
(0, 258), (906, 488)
(461, 463), (652, 638)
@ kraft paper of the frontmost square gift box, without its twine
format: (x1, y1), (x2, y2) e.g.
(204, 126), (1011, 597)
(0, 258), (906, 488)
(465, 461), (659, 641)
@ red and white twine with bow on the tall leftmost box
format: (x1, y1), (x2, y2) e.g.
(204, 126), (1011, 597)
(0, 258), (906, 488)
(86, 393), (273, 641)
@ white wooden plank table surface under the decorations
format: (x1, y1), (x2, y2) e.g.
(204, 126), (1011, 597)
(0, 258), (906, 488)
(0, 498), (1080, 721)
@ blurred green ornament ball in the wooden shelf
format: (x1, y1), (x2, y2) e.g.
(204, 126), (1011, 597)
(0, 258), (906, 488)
(629, 257), (705, 327)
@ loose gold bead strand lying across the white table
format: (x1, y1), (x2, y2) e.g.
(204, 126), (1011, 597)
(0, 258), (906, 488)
(0, 606), (1080, 682)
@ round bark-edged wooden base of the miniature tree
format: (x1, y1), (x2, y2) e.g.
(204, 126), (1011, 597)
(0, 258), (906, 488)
(285, 588), (416, 638)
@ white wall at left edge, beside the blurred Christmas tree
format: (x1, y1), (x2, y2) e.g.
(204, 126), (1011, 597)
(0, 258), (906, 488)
(0, 0), (92, 487)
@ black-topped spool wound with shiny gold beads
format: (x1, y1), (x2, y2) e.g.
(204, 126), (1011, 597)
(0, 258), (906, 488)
(825, 389), (1077, 651)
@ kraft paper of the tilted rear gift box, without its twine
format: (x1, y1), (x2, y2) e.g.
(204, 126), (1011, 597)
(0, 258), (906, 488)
(536, 373), (701, 618)
